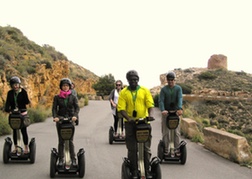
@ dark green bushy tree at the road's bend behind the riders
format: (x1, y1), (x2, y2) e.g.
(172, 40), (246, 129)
(92, 74), (115, 98)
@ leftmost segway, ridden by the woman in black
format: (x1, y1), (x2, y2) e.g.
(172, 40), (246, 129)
(3, 109), (36, 164)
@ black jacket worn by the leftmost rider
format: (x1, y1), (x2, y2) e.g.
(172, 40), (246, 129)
(4, 88), (30, 112)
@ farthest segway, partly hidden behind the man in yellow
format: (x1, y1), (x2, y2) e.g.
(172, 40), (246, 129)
(109, 117), (125, 144)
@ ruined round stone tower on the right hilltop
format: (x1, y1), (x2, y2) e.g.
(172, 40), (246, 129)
(207, 55), (227, 69)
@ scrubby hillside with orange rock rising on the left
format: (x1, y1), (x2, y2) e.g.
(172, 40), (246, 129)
(0, 26), (99, 108)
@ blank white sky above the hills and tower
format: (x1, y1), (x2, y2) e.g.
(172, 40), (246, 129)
(0, 0), (252, 88)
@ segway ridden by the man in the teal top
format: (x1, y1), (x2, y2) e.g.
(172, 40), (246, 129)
(157, 111), (187, 165)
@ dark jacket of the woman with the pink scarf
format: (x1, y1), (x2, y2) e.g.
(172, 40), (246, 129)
(52, 94), (80, 118)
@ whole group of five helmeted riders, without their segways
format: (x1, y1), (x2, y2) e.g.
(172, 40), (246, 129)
(1, 70), (183, 179)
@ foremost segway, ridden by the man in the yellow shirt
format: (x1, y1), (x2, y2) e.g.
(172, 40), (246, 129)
(121, 118), (161, 179)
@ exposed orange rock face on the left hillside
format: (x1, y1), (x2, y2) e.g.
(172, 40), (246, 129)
(0, 60), (96, 107)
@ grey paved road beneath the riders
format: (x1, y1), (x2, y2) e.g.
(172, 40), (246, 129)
(0, 101), (252, 179)
